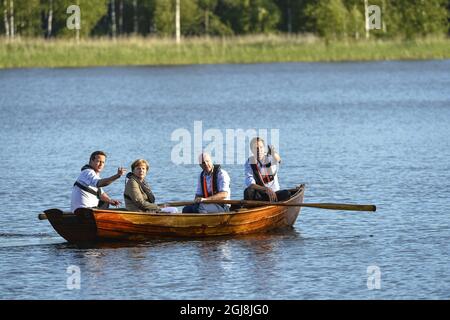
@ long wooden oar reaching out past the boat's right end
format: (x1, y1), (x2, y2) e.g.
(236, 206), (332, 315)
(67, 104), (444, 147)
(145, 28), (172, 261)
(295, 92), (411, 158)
(160, 200), (377, 211)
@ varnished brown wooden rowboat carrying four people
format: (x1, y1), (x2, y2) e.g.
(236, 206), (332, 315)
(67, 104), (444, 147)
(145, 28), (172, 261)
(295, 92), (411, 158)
(40, 184), (305, 243)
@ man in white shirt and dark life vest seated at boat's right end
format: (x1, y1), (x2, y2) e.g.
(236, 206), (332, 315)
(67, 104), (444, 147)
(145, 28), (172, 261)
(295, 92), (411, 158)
(244, 137), (291, 202)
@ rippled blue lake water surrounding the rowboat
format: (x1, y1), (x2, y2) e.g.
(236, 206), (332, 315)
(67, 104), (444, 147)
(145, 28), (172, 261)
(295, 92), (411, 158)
(0, 60), (450, 299)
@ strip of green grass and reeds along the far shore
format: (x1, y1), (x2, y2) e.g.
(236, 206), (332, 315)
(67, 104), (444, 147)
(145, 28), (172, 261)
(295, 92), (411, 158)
(0, 36), (450, 68)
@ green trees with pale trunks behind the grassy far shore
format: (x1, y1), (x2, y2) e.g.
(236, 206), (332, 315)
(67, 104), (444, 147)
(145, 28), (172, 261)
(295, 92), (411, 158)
(0, 0), (450, 39)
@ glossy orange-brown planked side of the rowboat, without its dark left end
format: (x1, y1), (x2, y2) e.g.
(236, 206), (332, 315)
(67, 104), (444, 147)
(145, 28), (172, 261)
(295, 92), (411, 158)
(91, 185), (304, 240)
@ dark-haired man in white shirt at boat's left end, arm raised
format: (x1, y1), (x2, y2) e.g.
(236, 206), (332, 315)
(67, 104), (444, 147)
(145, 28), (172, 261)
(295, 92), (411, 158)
(70, 151), (126, 212)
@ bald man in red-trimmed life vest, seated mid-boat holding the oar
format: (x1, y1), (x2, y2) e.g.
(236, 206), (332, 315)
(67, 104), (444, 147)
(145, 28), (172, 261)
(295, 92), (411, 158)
(183, 152), (231, 213)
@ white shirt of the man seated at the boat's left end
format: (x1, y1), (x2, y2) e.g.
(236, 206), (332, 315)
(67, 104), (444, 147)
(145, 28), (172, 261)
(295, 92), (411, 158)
(70, 169), (100, 212)
